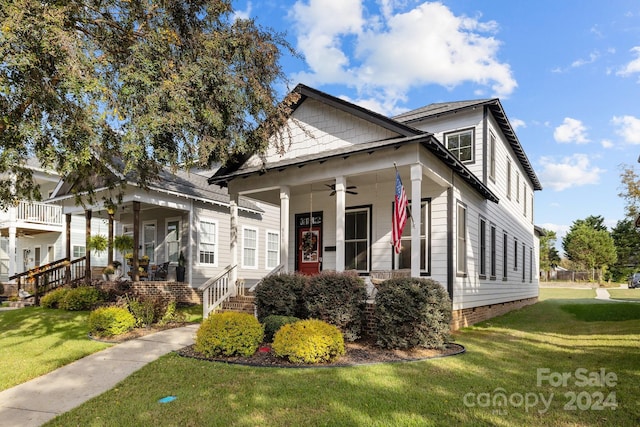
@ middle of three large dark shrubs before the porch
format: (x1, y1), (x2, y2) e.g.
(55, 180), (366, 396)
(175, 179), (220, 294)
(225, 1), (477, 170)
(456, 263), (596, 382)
(302, 272), (367, 341)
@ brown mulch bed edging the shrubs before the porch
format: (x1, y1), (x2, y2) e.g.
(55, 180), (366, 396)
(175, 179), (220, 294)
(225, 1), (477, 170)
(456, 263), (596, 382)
(178, 340), (465, 368)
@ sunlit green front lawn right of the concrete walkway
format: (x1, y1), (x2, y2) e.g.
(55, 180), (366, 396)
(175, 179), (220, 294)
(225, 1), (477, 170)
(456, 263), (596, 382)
(47, 289), (640, 427)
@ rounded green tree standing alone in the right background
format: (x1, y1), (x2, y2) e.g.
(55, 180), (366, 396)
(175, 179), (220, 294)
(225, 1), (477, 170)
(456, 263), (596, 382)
(562, 216), (617, 280)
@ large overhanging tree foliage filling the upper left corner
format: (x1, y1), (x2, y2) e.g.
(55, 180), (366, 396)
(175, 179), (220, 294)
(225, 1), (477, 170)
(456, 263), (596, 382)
(0, 0), (295, 207)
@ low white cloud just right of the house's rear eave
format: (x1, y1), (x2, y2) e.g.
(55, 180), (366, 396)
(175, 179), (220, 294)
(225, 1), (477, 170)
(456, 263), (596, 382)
(540, 154), (605, 191)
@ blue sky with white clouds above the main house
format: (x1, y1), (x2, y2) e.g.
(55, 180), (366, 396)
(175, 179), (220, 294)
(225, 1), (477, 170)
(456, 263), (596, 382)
(234, 0), (640, 254)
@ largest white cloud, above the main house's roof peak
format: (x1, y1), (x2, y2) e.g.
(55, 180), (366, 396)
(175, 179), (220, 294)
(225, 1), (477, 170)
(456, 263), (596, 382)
(290, 0), (517, 113)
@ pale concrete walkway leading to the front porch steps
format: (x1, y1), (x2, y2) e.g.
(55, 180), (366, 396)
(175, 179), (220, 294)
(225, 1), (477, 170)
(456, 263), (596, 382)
(0, 325), (200, 427)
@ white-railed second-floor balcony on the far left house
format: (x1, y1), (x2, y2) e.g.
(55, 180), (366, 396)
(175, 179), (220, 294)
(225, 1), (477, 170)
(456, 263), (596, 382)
(0, 201), (64, 230)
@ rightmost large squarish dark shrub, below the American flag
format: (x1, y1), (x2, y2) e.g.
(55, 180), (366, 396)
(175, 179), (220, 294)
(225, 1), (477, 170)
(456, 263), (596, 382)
(375, 278), (451, 349)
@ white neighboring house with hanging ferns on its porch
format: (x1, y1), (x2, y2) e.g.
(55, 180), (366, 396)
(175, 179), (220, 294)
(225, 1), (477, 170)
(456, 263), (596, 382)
(49, 164), (280, 289)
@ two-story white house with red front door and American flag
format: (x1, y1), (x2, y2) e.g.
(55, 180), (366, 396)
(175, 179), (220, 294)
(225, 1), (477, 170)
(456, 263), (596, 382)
(209, 85), (542, 326)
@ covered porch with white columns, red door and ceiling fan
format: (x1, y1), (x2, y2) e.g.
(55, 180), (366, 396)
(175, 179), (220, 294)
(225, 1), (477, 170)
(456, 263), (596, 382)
(211, 144), (452, 290)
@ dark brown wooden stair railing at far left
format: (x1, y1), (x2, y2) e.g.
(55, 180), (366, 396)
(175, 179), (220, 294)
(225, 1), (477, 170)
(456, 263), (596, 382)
(9, 257), (87, 305)
